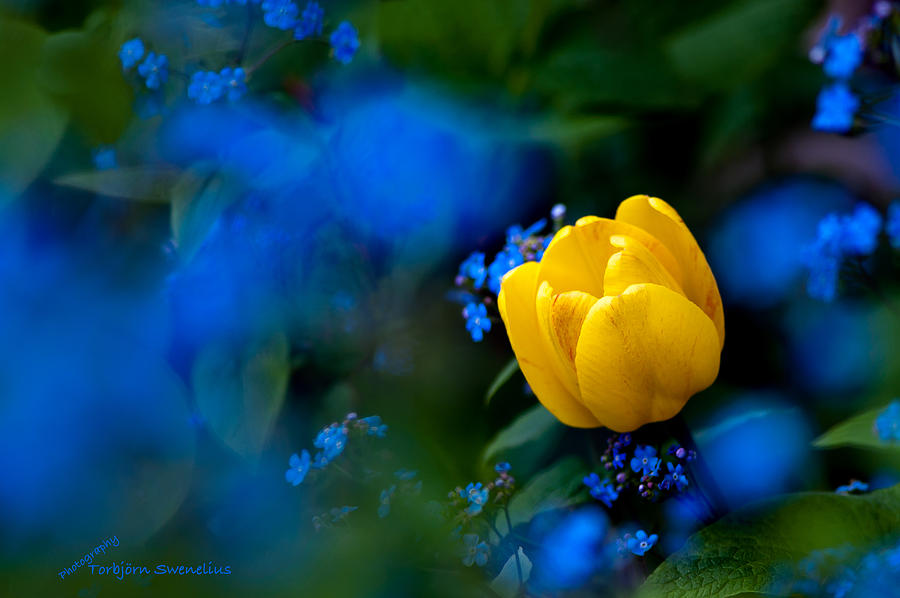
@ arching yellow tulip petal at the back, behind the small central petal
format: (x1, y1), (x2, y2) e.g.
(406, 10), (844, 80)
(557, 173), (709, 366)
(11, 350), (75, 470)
(540, 216), (681, 297)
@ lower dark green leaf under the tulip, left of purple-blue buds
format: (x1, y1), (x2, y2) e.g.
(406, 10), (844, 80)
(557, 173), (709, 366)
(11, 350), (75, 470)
(496, 457), (588, 534)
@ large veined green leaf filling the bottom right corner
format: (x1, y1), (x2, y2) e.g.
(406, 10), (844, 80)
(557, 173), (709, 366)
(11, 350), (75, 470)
(638, 486), (900, 598)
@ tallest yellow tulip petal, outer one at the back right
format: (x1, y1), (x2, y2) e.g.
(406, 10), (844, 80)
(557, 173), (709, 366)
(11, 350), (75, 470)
(616, 195), (725, 348)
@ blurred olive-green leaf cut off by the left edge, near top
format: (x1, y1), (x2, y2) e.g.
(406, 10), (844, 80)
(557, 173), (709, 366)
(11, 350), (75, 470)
(0, 17), (68, 194)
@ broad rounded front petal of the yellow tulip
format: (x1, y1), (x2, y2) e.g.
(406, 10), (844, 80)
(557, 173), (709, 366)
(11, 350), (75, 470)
(575, 284), (720, 432)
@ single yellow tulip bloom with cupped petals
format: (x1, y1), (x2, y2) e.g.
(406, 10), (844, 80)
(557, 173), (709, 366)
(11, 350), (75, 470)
(498, 195), (725, 432)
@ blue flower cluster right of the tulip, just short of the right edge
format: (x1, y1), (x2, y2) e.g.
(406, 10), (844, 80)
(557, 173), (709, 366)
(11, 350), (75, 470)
(803, 203), (882, 301)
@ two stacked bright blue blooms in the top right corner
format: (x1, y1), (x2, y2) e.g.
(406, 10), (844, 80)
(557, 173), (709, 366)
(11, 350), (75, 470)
(810, 17), (863, 133)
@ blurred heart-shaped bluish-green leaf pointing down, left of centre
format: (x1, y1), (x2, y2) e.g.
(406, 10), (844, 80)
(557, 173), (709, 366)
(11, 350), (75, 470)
(191, 333), (290, 458)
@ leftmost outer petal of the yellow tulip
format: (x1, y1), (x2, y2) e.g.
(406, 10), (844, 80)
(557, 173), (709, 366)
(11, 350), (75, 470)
(497, 262), (601, 428)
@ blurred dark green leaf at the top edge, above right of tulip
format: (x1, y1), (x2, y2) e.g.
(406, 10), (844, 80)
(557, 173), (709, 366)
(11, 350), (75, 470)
(665, 0), (816, 89)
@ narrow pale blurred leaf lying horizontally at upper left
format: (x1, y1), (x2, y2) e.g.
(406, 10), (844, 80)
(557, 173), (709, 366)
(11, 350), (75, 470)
(54, 166), (182, 202)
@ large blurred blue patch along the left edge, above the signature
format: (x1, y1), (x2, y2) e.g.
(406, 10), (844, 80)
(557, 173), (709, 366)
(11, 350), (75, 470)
(0, 210), (194, 551)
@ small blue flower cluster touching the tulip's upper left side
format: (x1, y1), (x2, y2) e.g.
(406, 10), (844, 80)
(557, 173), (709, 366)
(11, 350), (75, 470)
(455, 204), (566, 343)
